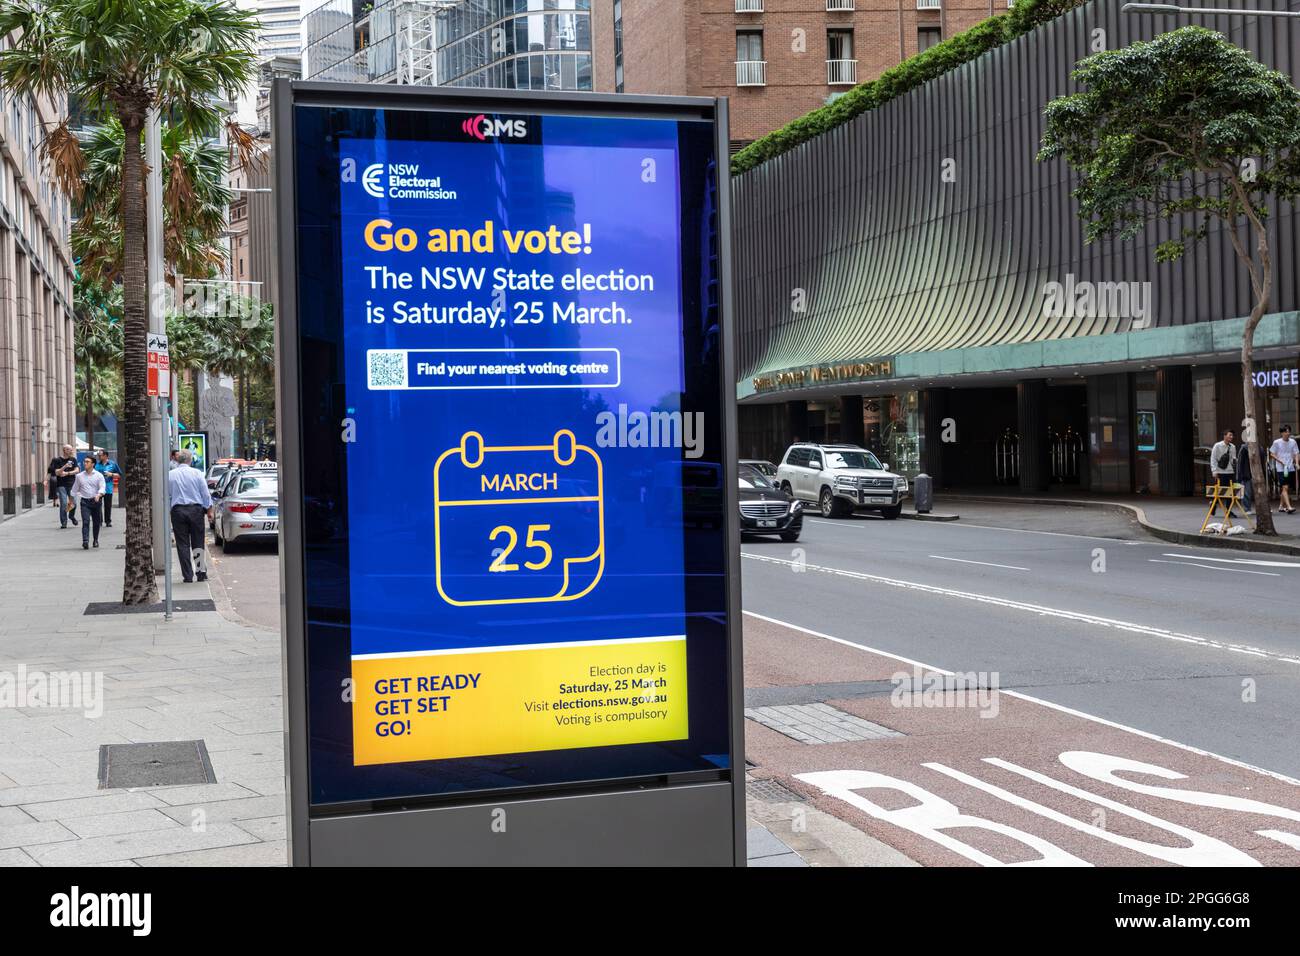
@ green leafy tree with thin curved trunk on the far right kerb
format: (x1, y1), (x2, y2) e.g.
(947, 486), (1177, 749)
(1039, 26), (1300, 535)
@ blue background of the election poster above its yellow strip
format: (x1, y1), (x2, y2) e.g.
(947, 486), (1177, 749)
(339, 117), (685, 654)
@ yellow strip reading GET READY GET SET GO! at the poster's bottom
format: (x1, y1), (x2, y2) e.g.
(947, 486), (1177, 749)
(352, 636), (689, 766)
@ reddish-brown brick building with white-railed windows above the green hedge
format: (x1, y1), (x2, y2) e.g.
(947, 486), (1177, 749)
(592, 0), (1006, 148)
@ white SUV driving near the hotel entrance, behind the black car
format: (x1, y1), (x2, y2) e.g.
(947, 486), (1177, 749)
(776, 442), (907, 520)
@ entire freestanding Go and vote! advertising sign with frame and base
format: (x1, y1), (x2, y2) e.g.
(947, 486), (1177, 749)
(274, 81), (745, 865)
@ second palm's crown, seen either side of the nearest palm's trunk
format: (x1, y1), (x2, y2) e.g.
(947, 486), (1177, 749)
(73, 118), (230, 287)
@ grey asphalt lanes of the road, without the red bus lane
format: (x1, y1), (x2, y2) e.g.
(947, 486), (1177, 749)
(742, 504), (1300, 777)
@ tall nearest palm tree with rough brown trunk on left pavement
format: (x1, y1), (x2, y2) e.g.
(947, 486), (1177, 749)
(0, 0), (259, 604)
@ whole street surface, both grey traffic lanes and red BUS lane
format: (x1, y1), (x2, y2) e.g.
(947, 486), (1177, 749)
(212, 503), (1300, 865)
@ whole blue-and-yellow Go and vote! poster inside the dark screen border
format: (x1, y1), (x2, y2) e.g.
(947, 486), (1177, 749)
(341, 116), (688, 765)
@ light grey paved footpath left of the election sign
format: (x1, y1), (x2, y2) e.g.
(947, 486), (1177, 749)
(0, 507), (286, 866)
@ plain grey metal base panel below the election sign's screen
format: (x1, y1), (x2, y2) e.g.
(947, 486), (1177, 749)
(301, 780), (744, 866)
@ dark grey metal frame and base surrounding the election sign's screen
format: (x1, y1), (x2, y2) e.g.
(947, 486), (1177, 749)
(272, 79), (745, 866)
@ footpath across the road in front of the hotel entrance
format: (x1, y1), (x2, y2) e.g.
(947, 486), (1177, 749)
(936, 488), (1300, 555)
